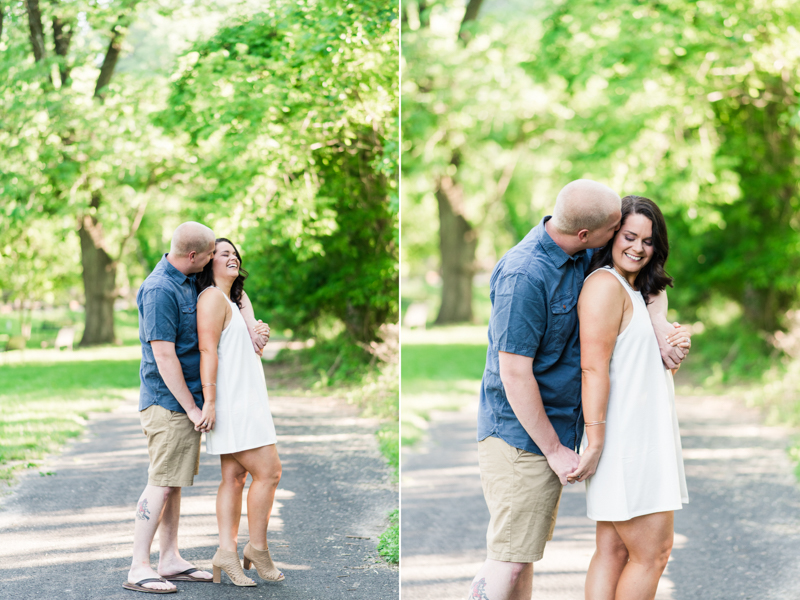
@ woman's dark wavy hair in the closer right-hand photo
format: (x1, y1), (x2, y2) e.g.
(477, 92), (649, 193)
(587, 196), (672, 304)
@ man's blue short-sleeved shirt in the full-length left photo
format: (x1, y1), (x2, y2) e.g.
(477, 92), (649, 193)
(136, 254), (203, 413)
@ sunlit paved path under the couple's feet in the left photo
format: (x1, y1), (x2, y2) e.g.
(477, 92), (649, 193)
(0, 397), (399, 600)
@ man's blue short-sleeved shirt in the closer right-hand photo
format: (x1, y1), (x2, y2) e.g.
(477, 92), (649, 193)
(478, 216), (592, 454)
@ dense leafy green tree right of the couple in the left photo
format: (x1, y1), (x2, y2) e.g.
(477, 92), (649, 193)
(158, 0), (398, 342)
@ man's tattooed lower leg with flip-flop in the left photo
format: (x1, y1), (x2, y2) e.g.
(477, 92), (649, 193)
(128, 485), (180, 590)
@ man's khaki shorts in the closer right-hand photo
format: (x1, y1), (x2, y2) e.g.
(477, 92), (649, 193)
(478, 436), (564, 563)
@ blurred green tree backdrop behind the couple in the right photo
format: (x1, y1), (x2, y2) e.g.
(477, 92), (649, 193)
(401, 0), (800, 384)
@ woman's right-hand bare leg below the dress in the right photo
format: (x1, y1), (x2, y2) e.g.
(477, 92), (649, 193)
(614, 511), (674, 600)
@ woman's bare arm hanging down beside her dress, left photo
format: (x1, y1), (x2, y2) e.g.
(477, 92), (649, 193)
(195, 290), (231, 431)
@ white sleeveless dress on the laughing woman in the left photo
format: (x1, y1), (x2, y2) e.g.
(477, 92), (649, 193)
(201, 288), (277, 454)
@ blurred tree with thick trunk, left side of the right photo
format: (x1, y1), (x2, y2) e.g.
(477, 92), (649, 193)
(403, 2), (566, 324)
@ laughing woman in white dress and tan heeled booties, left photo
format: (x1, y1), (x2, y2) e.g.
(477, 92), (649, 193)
(197, 238), (284, 586)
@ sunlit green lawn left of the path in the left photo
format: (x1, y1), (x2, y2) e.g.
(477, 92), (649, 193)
(0, 348), (139, 483)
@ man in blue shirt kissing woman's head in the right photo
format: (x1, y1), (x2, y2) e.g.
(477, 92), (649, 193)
(469, 179), (684, 600)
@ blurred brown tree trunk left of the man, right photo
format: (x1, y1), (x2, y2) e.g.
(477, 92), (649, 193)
(436, 171), (478, 325)
